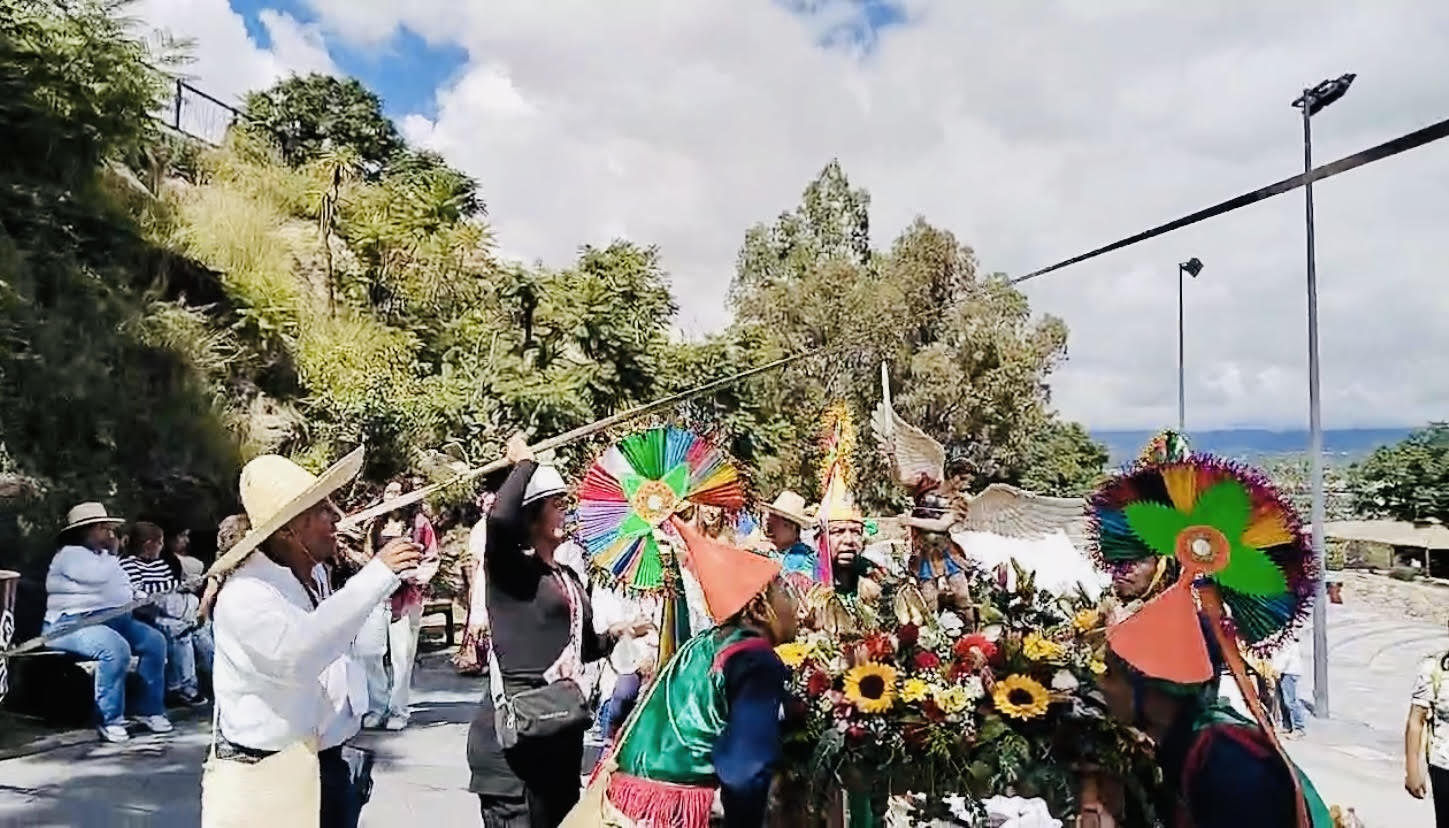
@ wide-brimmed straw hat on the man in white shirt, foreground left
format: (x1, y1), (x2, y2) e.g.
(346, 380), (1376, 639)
(207, 447), (364, 574)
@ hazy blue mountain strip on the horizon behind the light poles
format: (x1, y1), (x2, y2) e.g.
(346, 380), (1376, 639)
(1091, 428), (1411, 465)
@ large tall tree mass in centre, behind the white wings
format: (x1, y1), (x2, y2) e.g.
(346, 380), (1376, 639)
(718, 162), (1100, 508)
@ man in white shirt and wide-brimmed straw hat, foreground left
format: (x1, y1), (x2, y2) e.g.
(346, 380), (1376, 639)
(201, 448), (420, 827)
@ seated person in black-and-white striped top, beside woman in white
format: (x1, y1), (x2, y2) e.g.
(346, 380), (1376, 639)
(120, 521), (216, 708)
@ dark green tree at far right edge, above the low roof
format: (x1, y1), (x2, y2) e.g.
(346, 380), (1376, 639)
(1349, 422), (1449, 522)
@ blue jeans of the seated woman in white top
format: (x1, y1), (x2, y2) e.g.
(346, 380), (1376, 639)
(45, 615), (167, 725)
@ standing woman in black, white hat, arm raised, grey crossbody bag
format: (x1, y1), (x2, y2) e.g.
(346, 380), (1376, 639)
(468, 435), (652, 828)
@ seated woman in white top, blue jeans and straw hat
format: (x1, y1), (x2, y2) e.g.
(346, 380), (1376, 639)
(45, 503), (171, 742)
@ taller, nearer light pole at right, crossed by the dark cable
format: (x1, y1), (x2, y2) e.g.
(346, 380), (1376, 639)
(1293, 74), (1355, 718)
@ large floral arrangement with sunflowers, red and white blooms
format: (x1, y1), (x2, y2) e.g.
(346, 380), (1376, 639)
(778, 559), (1156, 821)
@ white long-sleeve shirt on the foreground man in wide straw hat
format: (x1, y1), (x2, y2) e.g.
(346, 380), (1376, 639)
(212, 552), (398, 750)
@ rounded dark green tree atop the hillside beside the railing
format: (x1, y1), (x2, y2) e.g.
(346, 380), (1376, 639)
(242, 73), (404, 175)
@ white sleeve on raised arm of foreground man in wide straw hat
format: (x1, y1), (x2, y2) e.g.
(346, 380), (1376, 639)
(216, 560), (398, 682)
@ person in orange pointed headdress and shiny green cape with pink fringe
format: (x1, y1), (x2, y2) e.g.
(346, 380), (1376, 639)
(564, 518), (796, 828)
